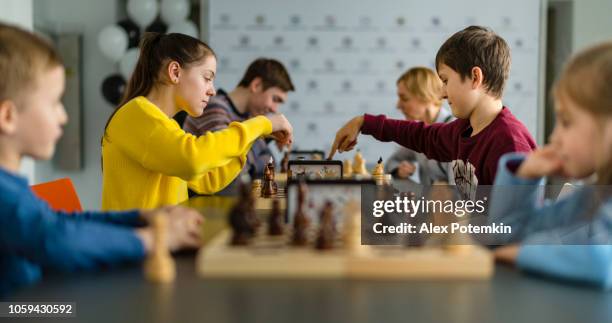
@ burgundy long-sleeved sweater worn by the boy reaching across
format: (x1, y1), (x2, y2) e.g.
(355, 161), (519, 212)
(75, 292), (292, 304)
(361, 107), (536, 197)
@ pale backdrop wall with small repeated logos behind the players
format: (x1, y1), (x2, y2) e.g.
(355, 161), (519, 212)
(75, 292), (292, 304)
(208, 0), (540, 162)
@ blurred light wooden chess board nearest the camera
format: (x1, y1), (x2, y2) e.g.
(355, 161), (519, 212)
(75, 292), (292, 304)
(196, 226), (493, 280)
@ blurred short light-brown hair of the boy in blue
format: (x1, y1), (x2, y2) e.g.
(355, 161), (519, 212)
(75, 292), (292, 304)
(0, 23), (62, 101)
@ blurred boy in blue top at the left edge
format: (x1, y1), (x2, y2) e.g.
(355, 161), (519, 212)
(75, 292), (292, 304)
(0, 23), (202, 295)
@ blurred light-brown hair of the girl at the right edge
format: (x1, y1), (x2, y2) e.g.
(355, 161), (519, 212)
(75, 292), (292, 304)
(552, 41), (612, 184)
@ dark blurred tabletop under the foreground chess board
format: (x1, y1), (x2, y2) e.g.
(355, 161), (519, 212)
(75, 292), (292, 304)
(9, 196), (612, 323)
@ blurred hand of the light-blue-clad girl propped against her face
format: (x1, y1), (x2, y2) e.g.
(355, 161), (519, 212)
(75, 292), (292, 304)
(516, 145), (565, 179)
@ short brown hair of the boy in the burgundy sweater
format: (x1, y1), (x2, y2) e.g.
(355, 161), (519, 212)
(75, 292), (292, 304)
(436, 26), (510, 98)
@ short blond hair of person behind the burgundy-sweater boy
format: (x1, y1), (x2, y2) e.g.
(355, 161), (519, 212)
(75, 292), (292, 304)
(397, 66), (442, 107)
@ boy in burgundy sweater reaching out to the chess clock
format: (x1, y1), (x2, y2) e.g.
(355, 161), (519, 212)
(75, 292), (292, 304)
(330, 26), (536, 198)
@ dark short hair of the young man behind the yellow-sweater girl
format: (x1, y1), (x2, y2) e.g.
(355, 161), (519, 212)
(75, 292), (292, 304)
(238, 58), (295, 92)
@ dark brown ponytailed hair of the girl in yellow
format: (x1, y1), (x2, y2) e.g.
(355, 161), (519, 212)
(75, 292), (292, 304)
(102, 32), (216, 138)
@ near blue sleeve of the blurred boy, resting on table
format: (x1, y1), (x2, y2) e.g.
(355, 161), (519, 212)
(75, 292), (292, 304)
(0, 201), (145, 271)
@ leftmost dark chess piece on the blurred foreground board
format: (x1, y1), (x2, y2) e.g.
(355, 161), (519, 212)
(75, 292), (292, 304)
(229, 182), (260, 246)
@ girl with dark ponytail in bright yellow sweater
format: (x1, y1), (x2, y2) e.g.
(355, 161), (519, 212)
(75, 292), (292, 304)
(102, 33), (293, 210)
